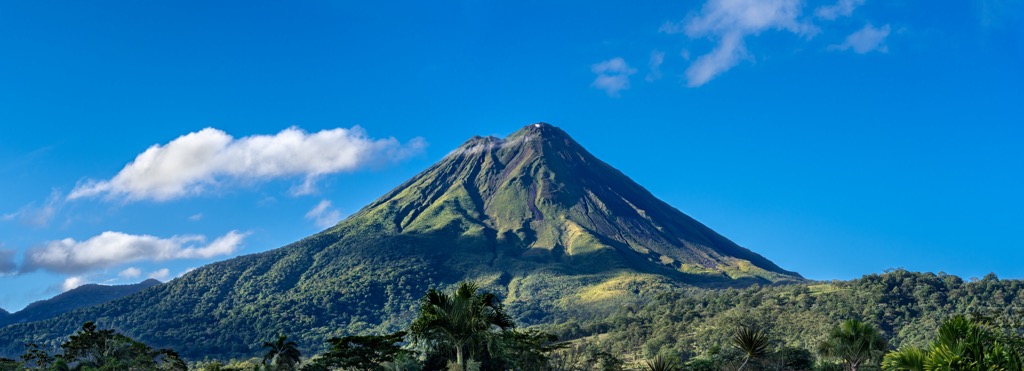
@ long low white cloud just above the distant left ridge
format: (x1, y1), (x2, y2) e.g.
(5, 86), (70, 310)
(23, 231), (246, 274)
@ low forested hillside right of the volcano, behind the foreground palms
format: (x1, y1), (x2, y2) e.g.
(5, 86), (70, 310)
(542, 270), (1024, 359)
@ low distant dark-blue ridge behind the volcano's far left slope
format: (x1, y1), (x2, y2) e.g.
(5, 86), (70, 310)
(0, 279), (160, 327)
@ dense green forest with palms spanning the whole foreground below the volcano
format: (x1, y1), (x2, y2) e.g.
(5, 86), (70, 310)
(0, 270), (1024, 371)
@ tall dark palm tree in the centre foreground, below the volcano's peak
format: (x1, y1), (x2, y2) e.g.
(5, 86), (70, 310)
(410, 282), (515, 370)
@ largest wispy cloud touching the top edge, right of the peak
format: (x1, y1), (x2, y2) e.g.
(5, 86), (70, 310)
(659, 0), (819, 87)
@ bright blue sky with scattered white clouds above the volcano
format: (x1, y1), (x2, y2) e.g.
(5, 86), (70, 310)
(0, 0), (1024, 311)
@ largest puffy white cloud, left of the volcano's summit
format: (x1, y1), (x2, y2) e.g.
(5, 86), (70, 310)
(68, 126), (426, 201)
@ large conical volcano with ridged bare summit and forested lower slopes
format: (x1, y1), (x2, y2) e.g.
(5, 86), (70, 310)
(0, 124), (802, 358)
